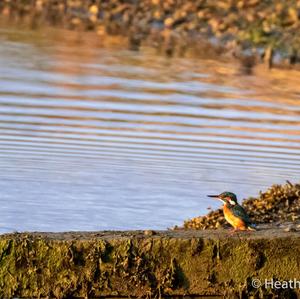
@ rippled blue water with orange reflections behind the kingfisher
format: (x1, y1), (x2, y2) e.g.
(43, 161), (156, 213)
(0, 27), (300, 232)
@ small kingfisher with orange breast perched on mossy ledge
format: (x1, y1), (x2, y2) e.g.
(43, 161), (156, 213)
(208, 192), (256, 231)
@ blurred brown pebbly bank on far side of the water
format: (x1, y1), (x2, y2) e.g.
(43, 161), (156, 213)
(0, 0), (300, 67)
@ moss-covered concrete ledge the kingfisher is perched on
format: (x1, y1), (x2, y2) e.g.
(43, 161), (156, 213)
(0, 226), (300, 298)
